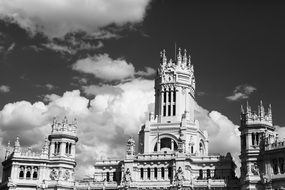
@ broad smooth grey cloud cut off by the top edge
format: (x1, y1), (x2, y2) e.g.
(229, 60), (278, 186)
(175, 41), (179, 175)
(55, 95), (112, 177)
(0, 0), (150, 36)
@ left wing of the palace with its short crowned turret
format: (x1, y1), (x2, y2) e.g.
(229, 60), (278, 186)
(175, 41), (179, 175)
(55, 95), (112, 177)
(0, 118), (78, 190)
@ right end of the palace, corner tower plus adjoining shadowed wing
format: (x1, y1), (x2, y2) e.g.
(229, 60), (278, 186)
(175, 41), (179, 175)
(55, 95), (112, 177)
(239, 101), (285, 189)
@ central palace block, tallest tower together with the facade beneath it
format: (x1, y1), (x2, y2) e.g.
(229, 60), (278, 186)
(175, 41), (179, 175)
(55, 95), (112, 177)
(91, 49), (239, 189)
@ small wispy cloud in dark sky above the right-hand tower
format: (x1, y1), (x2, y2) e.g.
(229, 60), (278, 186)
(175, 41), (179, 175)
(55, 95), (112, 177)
(226, 84), (256, 101)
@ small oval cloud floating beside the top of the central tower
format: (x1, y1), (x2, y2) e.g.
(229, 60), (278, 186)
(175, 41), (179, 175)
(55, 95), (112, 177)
(72, 54), (155, 81)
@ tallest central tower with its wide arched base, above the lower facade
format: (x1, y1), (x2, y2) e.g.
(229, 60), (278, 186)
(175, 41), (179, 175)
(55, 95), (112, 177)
(138, 48), (208, 156)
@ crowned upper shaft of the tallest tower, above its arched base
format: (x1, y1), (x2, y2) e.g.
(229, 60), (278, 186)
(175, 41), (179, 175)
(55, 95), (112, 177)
(155, 48), (195, 123)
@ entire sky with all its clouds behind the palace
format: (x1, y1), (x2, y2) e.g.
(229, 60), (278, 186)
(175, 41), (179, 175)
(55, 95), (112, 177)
(0, 0), (285, 178)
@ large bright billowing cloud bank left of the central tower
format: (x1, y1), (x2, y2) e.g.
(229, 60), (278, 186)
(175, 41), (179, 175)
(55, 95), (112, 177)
(0, 79), (154, 177)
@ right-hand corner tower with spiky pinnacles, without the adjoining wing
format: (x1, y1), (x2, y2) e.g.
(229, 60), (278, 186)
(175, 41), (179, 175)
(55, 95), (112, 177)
(239, 101), (275, 189)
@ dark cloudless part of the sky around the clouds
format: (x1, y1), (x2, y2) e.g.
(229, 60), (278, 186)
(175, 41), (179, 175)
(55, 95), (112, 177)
(0, 0), (285, 125)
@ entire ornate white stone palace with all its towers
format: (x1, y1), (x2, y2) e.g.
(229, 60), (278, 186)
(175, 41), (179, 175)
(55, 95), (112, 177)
(0, 49), (285, 190)
